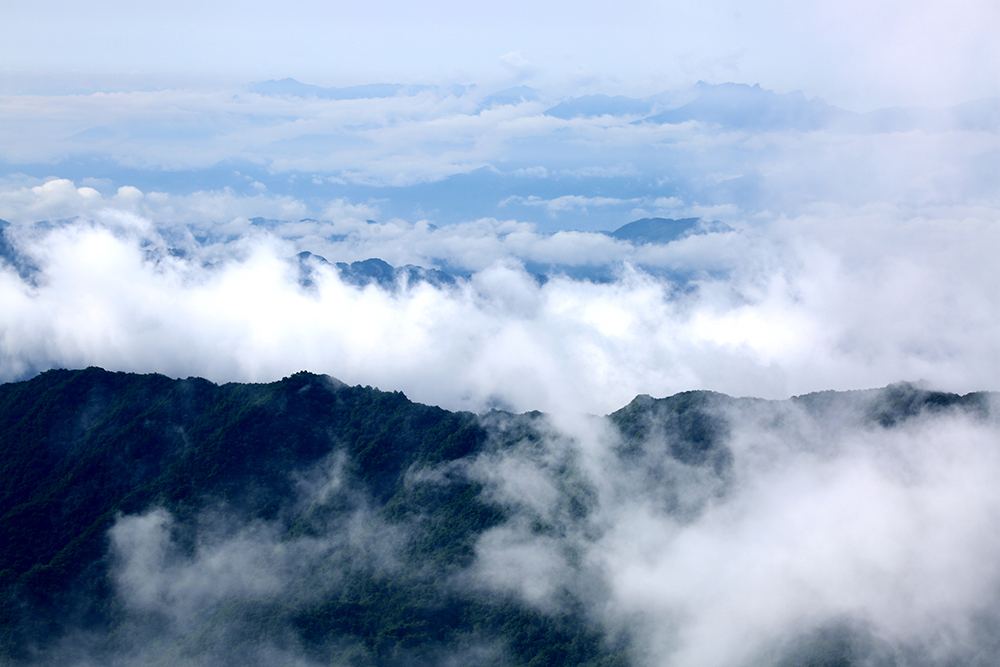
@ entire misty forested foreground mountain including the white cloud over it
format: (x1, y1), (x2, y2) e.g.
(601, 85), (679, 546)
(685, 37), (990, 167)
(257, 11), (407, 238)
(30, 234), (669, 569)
(0, 368), (1000, 665)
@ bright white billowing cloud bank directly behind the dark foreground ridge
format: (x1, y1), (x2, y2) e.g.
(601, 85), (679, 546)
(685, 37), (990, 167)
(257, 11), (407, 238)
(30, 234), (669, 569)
(0, 193), (1000, 413)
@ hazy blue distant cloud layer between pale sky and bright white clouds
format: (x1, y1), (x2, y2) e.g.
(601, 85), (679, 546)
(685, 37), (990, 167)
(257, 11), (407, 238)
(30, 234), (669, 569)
(0, 79), (1000, 231)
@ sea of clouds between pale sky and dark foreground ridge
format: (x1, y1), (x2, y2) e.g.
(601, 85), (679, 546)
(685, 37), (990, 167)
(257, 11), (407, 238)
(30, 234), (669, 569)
(0, 82), (1000, 413)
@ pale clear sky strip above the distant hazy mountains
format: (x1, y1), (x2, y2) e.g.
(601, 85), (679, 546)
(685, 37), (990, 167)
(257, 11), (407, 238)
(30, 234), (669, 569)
(0, 0), (1000, 111)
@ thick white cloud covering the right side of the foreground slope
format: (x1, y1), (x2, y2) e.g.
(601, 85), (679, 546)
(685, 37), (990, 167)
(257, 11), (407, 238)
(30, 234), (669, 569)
(466, 399), (1000, 667)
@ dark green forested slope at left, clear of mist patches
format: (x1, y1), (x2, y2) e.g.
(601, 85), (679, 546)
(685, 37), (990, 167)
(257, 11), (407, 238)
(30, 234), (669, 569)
(0, 368), (620, 665)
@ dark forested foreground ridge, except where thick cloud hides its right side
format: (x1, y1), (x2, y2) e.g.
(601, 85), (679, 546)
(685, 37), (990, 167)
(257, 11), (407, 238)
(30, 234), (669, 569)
(0, 368), (993, 667)
